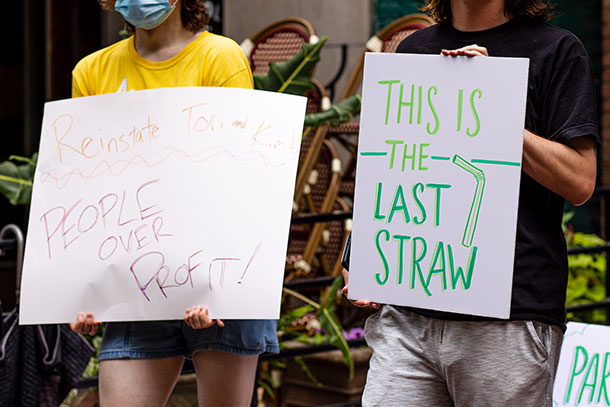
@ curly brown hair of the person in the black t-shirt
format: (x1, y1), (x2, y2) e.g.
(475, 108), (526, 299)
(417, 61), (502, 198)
(420, 0), (553, 23)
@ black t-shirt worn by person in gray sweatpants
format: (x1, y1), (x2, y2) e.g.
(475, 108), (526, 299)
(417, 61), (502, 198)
(396, 20), (599, 329)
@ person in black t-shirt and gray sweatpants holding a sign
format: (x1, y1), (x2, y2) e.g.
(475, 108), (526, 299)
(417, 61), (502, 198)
(344, 0), (599, 407)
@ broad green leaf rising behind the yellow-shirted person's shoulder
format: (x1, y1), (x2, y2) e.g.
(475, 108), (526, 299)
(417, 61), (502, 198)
(254, 37), (328, 95)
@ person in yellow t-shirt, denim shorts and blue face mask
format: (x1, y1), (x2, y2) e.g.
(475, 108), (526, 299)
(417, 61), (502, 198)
(71, 0), (279, 407)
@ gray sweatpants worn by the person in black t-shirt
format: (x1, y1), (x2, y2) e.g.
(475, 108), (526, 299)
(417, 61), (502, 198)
(362, 305), (563, 407)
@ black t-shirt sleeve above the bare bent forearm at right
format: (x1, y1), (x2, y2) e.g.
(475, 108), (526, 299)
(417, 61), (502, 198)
(539, 49), (600, 149)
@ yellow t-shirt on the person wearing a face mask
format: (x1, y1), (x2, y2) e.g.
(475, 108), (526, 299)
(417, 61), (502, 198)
(72, 31), (253, 97)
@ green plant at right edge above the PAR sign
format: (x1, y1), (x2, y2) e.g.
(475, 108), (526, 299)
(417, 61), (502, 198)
(564, 213), (607, 324)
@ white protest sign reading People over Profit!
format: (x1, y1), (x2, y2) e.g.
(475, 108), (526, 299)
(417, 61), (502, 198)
(20, 87), (306, 324)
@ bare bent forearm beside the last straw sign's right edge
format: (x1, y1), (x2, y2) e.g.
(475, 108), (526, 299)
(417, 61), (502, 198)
(523, 130), (597, 205)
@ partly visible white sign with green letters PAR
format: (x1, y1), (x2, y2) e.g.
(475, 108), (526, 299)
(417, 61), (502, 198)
(553, 322), (610, 407)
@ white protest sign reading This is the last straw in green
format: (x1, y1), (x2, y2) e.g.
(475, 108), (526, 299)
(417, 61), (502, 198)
(349, 54), (528, 318)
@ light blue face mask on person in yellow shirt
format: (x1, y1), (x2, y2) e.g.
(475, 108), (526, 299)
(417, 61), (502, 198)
(114, 0), (178, 30)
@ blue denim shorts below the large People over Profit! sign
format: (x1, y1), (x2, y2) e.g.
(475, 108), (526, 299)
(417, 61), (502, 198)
(98, 320), (279, 361)
